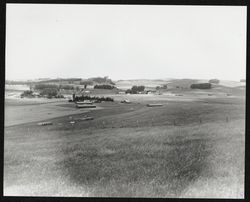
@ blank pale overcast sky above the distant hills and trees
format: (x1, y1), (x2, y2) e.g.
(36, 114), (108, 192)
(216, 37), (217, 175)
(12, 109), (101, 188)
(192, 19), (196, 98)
(6, 4), (246, 80)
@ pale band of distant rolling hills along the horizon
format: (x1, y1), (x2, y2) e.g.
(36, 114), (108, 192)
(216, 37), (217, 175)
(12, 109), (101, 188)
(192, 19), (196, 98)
(6, 76), (246, 92)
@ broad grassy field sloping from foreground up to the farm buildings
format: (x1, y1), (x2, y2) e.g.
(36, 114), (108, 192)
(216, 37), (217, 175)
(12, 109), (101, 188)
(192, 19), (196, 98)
(4, 87), (245, 198)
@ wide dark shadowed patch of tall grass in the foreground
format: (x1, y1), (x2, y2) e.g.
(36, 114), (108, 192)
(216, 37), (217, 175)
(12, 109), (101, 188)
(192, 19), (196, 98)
(57, 127), (212, 197)
